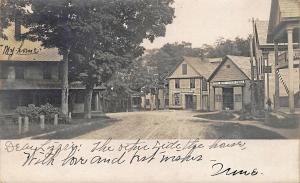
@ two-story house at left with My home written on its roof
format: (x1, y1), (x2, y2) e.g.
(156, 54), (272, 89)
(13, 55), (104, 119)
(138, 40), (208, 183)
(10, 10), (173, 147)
(0, 24), (101, 113)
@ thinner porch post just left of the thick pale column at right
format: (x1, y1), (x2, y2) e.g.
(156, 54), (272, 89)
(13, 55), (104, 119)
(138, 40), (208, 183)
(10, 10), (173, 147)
(273, 42), (280, 112)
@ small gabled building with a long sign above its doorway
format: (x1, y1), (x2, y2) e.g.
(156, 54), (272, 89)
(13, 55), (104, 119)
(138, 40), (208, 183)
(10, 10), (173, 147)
(208, 55), (251, 111)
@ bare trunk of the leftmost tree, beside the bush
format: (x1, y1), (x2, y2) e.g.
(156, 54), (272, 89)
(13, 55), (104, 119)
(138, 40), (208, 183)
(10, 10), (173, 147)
(61, 50), (70, 116)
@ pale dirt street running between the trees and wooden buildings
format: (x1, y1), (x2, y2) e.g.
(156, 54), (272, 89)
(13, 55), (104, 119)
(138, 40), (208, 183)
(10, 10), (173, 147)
(76, 111), (284, 139)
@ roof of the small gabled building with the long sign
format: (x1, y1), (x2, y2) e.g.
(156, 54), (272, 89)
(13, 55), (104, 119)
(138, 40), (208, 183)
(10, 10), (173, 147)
(208, 55), (251, 81)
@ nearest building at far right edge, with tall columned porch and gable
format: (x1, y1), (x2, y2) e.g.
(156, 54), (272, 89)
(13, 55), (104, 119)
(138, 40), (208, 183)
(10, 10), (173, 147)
(267, 0), (300, 113)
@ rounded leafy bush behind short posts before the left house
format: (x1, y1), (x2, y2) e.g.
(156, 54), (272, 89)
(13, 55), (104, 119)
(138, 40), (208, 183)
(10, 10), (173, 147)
(16, 103), (59, 122)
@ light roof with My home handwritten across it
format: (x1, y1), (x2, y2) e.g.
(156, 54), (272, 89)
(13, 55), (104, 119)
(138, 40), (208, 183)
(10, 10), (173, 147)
(0, 23), (62, 62)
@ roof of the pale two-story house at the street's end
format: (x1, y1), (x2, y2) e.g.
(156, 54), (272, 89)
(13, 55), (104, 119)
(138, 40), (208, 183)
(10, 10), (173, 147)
(168, 56), (221, 79)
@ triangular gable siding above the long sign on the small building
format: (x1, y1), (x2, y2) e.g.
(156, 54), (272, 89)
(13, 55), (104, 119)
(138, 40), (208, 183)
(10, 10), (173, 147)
(211, 59), (248, 81)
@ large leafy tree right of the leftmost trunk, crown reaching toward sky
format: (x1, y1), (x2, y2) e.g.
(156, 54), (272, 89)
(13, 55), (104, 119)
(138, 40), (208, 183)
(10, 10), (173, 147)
(67, 0), (174, 118)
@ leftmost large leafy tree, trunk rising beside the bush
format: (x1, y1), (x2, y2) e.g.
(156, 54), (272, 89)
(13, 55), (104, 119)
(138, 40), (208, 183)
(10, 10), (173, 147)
(1, 0), (86, 115)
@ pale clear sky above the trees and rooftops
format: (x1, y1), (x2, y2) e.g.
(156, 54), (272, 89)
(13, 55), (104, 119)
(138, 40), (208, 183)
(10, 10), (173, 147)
(143, 0), (271, 49)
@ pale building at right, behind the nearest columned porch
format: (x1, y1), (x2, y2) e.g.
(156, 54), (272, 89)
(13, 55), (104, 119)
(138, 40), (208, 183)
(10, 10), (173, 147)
(253, 20), (300, 107)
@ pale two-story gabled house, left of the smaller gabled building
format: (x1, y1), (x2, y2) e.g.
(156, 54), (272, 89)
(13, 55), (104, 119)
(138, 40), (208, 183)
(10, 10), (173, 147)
(168, 57), (221, 110)
